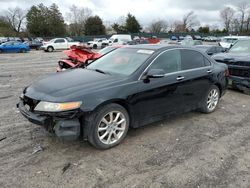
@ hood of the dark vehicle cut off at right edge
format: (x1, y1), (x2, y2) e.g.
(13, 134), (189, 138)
(212, 52), (250, 62)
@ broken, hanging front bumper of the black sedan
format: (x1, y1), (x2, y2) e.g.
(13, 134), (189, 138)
(17, 99), (81, 140)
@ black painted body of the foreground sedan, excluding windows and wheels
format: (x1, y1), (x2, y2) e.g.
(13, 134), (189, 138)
(19, 45), (227, 140)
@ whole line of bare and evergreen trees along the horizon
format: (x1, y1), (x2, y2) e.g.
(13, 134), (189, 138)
(0, 3), (250, 37)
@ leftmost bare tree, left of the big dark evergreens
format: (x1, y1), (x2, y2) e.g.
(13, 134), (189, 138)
(5, 7), (26, 33)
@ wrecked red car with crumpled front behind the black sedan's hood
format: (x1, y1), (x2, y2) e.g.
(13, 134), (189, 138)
(56, 45), (122, 72)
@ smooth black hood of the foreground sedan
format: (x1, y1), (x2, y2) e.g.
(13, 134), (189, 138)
(24, 68), (125, 102)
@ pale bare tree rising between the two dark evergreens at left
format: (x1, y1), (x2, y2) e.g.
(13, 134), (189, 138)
(66, 5), (92, 36)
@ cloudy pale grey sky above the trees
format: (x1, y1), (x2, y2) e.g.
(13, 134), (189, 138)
(0, 0), (247, 28)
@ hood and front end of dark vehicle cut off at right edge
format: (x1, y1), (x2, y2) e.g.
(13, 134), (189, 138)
(213, 53), (250, 91)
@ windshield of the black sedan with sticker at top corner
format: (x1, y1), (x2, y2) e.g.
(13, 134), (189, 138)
(87, 48), (154, 76)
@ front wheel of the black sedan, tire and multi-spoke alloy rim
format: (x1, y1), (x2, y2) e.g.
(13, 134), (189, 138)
(85, 104), (129, 149)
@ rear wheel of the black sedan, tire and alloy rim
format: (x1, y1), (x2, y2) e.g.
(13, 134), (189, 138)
(200, 85), (220, 114)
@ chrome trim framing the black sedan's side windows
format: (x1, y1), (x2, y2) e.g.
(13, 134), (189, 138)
(138, 48), (213, 80)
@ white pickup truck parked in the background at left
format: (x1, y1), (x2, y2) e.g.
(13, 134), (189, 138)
(41, 38), (80, 52)
